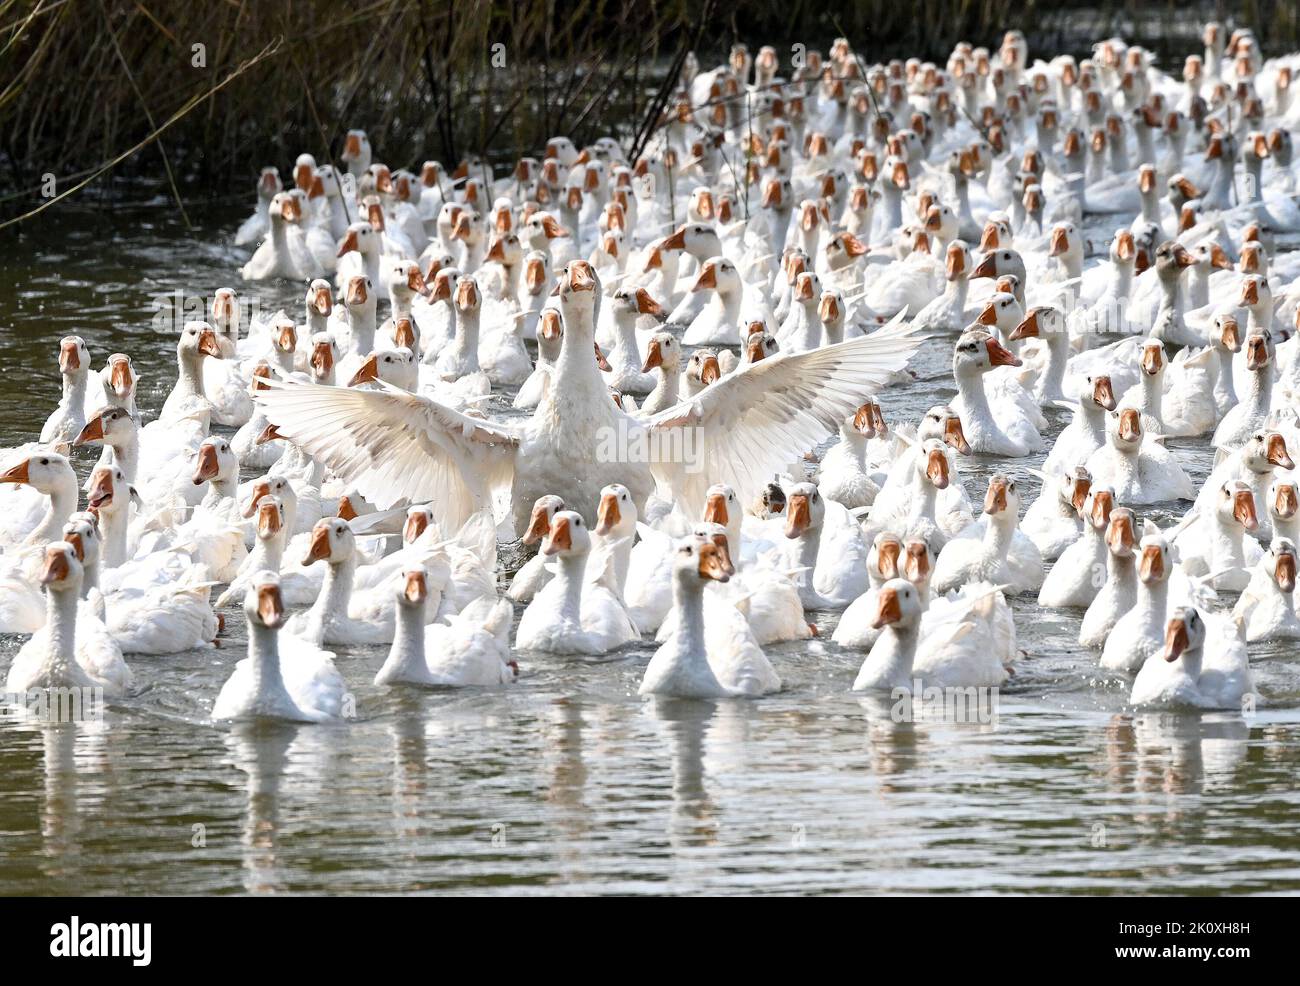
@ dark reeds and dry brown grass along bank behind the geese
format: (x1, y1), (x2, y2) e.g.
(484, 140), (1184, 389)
(0, 0), (1300, 222)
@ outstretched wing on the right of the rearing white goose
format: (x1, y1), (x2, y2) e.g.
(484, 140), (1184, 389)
(645, 313), (923, 516)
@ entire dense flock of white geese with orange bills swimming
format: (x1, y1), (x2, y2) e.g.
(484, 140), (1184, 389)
(0, 23), (1300, 722)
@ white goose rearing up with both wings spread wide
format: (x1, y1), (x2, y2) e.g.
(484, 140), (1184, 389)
(257, 260), (922, 532)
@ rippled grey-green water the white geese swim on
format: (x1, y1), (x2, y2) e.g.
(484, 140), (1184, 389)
(0, 198), (1300, 895)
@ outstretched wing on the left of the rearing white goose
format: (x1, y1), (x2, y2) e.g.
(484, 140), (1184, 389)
(257, 381), (520, 529)
